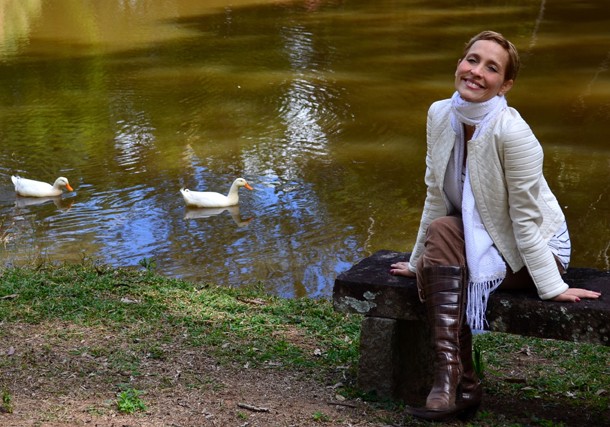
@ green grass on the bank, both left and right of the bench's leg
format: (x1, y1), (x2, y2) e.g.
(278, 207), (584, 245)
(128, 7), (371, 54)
(0, 262), (610, 426)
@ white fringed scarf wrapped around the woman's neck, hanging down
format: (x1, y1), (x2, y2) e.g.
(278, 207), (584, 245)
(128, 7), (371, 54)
(451, 92), (507, 329)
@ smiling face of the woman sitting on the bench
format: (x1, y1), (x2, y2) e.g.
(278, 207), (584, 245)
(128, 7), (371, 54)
(455, 40), (513, 102)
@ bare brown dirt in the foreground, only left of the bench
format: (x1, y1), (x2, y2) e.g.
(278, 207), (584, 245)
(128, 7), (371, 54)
(0, 331), (394, 427)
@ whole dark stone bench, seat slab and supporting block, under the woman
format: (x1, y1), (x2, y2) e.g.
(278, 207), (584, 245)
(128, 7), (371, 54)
(333, 250), (610, 402)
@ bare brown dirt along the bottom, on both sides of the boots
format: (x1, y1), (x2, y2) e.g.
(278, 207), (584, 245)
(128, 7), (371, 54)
(0, 323), (610, 427)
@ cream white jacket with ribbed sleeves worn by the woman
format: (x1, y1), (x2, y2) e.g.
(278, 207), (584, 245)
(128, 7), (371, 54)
(410, 99), (568, 299)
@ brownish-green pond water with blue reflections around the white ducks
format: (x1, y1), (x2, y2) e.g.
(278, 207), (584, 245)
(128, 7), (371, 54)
(0, 0), (610, 297)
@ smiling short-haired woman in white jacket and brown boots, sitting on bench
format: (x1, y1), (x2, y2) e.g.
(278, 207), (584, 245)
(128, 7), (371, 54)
(390, 31), (600, 420)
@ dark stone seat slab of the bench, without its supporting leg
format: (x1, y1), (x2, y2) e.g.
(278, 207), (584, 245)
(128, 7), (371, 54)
(333, 250), (610, 346)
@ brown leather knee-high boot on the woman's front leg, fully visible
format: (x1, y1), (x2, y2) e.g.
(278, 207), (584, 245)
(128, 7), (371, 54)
(407, 266), (466, 420)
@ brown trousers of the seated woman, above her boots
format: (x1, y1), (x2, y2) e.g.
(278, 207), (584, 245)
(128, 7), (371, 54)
(417, 216), (548, 289)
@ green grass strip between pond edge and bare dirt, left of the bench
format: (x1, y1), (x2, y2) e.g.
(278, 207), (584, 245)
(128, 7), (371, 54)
(0, 264), (359, 373)
